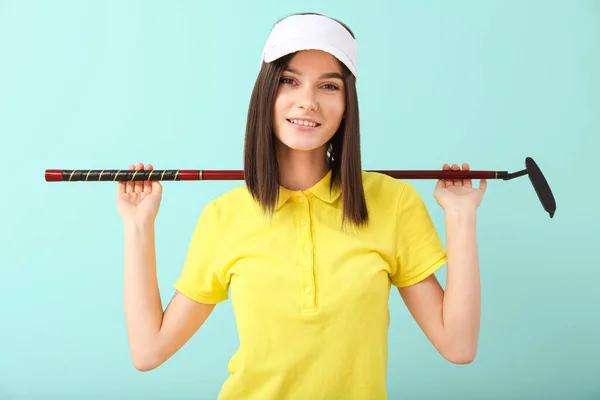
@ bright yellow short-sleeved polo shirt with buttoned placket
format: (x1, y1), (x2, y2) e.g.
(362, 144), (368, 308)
(175, 172), (447, 400)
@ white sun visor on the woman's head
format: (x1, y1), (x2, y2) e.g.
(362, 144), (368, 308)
(261, 15), (358, 76)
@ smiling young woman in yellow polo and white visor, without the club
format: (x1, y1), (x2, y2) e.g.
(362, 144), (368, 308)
(118, 14), (486, 400)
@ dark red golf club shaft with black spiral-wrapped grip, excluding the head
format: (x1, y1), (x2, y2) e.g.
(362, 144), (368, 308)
(45, 169), (506, 182)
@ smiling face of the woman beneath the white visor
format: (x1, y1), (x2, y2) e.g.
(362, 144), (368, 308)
(273, 50), (345, 151)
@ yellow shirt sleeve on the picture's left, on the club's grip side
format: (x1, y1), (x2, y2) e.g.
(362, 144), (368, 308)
(173, 201), (229, 304)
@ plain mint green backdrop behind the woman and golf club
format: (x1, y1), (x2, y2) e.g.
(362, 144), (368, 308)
(0, 0), (600, 400)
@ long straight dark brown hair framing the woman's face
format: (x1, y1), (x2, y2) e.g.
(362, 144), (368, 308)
(244, 13), (368, 226)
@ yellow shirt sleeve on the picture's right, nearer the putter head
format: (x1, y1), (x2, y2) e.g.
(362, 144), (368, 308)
(391, 183), (448, 287)
